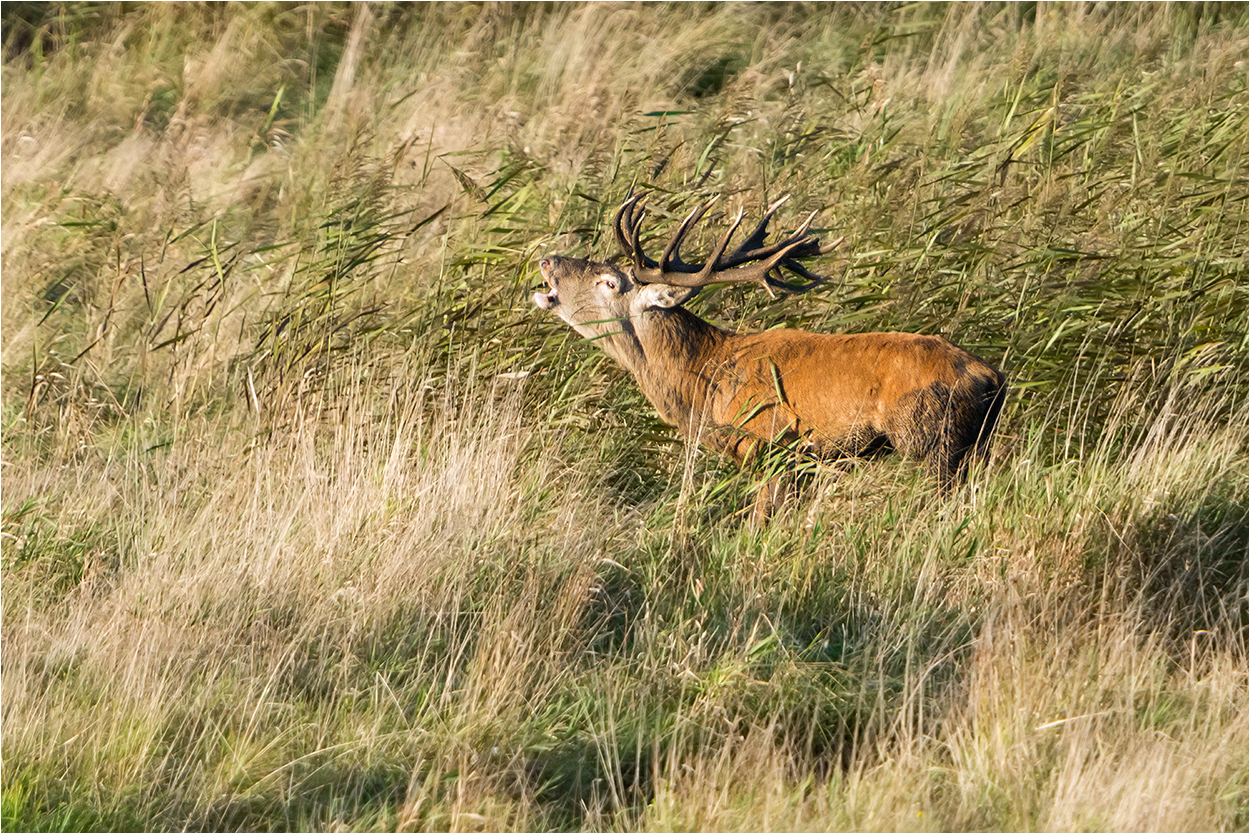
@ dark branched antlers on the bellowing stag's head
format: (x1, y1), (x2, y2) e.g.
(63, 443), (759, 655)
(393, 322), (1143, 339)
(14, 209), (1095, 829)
(613, 194), (843, 293)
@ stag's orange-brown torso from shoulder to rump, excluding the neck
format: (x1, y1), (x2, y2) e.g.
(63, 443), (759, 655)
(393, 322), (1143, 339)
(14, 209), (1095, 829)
(709, 330), (1004, 485)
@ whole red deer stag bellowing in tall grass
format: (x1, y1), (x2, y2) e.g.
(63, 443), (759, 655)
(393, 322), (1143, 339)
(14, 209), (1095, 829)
(534, 195), (1005, 523)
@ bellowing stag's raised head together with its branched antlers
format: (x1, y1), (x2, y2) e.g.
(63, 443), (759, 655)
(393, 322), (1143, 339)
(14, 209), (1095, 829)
(534, 194), (839, 346)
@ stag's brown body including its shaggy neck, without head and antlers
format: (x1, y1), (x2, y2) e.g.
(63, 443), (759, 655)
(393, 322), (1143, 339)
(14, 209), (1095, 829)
(617, 308), (1004, 488)
